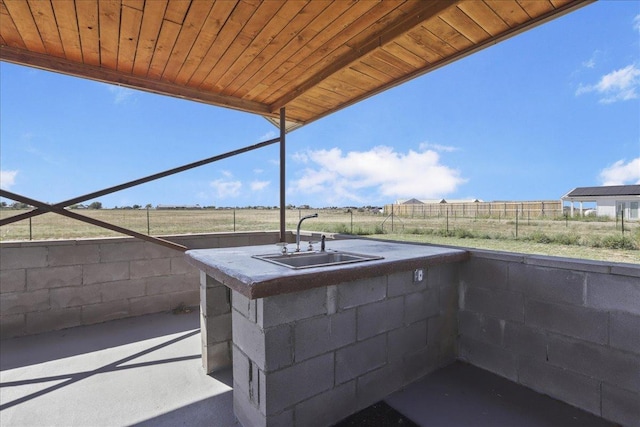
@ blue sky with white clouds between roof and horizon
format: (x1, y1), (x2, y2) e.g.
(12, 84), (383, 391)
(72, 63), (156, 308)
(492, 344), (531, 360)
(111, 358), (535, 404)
(0, 1), (640, 207)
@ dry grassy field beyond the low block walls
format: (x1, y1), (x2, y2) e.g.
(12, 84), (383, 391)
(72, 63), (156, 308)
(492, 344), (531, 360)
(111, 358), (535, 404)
(0, 209), (640, 263)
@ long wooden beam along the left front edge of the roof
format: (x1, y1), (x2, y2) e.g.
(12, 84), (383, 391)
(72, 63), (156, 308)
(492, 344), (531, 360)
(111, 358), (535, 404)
(0, 45), (278, 117)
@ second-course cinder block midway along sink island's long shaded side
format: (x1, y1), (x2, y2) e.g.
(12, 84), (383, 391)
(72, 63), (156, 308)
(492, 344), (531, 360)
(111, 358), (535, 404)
(357, 296), (404, 340)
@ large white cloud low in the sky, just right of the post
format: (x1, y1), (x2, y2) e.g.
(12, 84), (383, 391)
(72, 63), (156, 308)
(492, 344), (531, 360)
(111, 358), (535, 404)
(289, 146), (465, 204)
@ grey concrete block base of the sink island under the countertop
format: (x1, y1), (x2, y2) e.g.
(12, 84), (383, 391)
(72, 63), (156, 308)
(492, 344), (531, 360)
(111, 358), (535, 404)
(226, 264), (459, 427)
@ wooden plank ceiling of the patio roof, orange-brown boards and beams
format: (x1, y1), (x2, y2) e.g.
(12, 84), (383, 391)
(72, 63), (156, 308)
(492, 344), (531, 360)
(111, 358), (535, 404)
(0, 0), (590, 124)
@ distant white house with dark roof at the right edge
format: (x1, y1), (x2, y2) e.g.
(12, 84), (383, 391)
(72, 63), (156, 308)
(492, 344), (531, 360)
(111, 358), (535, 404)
(561, 185), (640, 220)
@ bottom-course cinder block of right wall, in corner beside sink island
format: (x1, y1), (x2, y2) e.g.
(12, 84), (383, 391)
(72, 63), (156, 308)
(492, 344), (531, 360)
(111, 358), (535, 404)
(459, 336), (518, 381)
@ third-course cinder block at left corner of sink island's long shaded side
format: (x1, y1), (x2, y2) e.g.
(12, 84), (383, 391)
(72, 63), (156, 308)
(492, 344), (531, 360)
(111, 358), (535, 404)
(264, 353), (334, 416)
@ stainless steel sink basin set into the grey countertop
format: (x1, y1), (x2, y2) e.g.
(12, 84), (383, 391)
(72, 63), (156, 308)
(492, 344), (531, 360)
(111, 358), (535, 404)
(252, 251), (383, 269)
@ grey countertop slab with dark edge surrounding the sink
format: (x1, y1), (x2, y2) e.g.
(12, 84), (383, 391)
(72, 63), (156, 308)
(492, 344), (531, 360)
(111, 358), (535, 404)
(186, 239), (468, 299)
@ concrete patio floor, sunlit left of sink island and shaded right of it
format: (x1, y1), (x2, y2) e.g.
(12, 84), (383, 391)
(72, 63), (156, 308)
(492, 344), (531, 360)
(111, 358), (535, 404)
(0, 312), (615, 427)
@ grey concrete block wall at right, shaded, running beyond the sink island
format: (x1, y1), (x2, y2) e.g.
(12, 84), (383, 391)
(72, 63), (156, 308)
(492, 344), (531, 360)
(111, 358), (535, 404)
(458, 250), (640, 426)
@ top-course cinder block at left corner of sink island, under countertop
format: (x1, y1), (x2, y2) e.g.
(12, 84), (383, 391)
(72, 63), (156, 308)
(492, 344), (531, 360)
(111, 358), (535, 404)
(256, 287), (327, 328)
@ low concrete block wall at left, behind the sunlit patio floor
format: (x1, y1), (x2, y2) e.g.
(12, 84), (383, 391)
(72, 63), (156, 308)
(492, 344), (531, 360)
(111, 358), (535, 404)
(0, 232), (278, 339)
